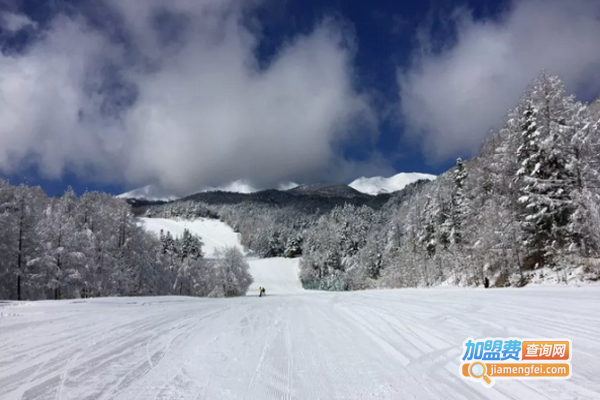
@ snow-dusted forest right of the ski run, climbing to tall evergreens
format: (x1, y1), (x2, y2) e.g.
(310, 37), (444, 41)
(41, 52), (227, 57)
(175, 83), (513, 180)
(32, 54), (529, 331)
(149, 72), (600, 290)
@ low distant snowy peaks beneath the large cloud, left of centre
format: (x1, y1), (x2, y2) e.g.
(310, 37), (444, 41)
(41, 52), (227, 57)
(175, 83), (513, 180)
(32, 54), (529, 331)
(117, 179), (298, 201)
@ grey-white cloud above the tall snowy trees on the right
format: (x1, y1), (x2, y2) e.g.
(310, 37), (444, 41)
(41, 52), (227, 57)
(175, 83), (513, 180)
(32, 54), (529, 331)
(398, 0), (600, 162)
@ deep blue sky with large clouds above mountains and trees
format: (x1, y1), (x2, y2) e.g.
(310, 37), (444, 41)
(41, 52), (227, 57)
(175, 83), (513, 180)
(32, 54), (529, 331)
(0, 0), (600, 195)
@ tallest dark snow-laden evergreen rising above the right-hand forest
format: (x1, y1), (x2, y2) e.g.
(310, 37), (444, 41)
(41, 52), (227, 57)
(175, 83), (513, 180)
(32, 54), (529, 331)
(517, 73), (573, 266)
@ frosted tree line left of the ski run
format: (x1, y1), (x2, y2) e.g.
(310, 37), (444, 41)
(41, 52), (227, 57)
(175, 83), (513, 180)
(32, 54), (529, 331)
(0, 185), (251, 300)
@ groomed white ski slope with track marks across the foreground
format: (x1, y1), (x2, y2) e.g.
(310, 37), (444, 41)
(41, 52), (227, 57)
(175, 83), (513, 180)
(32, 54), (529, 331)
(0, 221), (600, 400)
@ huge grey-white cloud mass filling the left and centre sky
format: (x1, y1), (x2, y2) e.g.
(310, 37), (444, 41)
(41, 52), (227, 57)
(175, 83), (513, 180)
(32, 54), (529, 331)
(0, 0), (376, 192)
